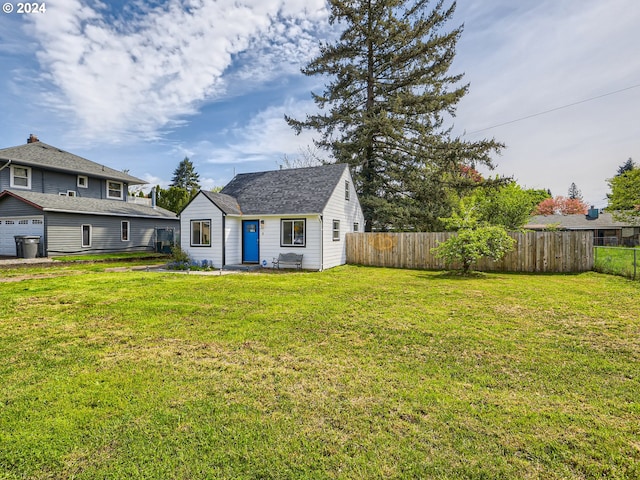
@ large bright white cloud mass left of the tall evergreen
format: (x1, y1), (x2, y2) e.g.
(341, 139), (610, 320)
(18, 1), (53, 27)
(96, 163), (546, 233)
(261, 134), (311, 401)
(23, 0), (326, 141)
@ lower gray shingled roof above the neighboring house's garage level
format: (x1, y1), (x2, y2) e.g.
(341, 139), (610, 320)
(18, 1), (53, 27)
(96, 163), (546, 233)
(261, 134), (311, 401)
(0, 190), (177, 219)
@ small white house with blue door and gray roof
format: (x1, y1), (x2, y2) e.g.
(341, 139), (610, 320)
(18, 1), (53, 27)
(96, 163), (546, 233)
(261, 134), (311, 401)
(180, 164), (364, 270)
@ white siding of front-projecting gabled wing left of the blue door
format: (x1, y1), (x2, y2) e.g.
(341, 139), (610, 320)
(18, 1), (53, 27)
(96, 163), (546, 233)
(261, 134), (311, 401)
(180, 193), (223, 268)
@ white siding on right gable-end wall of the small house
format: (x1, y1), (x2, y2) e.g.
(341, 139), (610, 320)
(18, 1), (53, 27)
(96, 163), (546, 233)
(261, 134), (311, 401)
(322, 169), (364, 269)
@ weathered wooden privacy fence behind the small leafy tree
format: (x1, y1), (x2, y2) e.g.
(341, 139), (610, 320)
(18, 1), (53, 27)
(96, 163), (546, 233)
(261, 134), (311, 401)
(346, 231), (593, 273)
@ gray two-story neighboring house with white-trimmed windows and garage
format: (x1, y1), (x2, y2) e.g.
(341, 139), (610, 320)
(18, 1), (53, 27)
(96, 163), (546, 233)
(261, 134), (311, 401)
(0, 135), (179, 256)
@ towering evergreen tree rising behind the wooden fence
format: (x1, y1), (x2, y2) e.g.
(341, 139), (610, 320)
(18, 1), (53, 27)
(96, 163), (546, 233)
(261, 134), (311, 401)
(285, 0), (502, 230)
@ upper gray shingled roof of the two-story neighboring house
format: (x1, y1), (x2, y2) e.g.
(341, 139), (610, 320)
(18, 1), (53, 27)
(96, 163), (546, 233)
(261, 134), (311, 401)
(0, 142), (147, 185)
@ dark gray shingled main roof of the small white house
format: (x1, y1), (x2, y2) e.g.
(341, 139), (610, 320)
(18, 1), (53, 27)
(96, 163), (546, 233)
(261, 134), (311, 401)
(221, 163), (348, 215)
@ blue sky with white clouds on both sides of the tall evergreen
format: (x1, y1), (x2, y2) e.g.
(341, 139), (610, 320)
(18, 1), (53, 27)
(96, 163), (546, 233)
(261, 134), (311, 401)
(0, 0), (640, 207)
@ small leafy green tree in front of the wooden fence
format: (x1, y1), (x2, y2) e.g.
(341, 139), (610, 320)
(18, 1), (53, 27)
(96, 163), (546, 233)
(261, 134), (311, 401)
(431, 200), (515, 275)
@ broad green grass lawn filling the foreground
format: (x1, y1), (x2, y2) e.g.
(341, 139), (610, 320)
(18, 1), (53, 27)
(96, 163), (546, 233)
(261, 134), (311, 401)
(0, 266), (640, 479)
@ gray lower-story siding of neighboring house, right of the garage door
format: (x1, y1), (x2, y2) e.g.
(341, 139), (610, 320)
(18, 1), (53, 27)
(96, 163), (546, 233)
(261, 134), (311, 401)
(46, 212), (170, 255)
